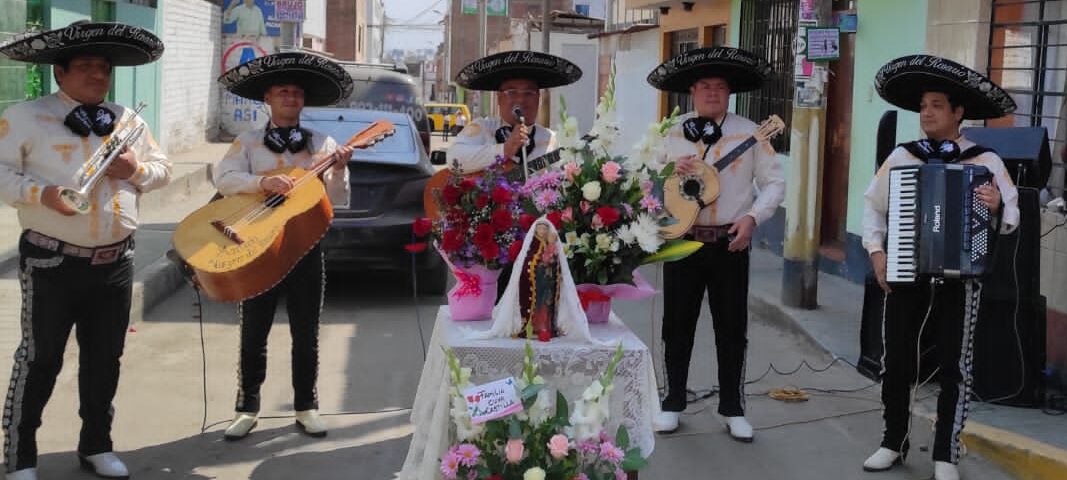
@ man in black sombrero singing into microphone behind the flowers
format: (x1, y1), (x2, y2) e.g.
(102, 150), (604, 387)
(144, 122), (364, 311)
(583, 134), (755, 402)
(448, 51), (582, 173)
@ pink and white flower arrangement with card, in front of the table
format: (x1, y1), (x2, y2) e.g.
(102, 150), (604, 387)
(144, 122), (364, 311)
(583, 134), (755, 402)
(441, 332), (647, 480)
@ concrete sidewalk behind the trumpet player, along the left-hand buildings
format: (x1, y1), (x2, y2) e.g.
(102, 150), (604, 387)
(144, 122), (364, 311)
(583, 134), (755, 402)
(0, 143), (229, 380)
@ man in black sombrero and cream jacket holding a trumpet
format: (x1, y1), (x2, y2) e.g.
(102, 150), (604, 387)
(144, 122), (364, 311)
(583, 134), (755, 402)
(0, 21), (171, 480)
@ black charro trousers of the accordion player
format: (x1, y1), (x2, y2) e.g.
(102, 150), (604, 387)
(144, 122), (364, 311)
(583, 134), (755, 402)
(881, 279), (982, 463)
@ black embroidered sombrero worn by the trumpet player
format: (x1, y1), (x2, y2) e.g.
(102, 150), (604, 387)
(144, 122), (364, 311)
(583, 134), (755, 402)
(0, 20), (163, 66)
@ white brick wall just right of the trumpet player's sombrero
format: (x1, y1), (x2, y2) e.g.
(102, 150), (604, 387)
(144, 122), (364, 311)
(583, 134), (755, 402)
(159, 0), (222, 154)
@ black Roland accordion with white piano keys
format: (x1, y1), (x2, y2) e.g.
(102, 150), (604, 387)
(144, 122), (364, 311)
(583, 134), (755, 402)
(886, 163), (997, 283)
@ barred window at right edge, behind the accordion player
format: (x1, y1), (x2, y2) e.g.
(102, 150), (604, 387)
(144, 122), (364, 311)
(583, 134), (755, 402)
(989, 0), (1067, 196)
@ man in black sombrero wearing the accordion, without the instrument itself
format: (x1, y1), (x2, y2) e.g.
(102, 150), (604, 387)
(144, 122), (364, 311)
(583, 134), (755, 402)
(863, 54), (1019, 480)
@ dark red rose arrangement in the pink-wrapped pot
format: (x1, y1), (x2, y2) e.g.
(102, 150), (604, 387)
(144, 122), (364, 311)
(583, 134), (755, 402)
(408, 157), (526, 270)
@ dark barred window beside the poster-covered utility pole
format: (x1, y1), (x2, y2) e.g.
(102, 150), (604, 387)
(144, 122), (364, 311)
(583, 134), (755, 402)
(736, 0), (799, 154)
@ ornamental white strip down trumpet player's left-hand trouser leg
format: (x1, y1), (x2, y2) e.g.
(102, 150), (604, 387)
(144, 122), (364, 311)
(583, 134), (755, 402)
(3, 255), (64, 473)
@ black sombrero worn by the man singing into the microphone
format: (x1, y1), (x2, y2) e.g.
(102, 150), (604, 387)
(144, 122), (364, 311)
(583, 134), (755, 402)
(456, 50), (582, 91)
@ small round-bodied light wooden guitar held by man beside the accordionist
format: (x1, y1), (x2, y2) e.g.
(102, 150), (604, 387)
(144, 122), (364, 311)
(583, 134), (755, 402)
(659, 115), (785, 240)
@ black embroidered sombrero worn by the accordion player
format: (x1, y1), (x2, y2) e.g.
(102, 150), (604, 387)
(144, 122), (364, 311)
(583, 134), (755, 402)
(874, 54), (1016, 119)
